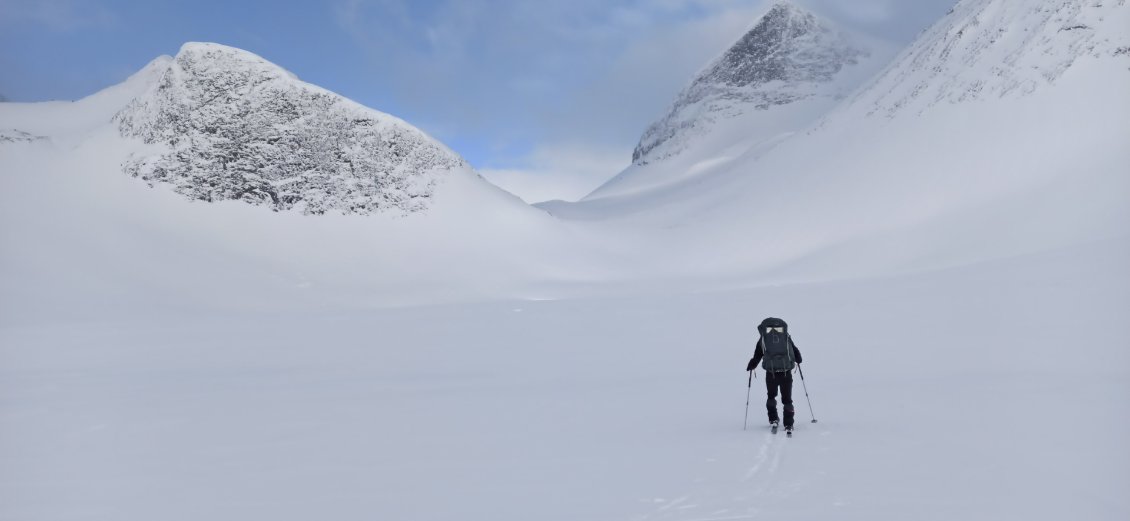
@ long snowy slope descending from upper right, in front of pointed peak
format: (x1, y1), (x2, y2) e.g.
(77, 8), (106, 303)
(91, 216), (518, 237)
(542, 0), (1130, 280)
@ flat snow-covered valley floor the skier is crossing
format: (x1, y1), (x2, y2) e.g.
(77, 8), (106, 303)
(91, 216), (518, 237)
(0, 236), (1130, 521)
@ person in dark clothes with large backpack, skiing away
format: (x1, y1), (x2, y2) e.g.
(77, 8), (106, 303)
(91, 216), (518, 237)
(746, 316), (801, 434)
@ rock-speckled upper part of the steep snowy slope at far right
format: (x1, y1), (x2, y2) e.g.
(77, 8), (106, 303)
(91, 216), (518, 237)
(853, 0), (1130, 118)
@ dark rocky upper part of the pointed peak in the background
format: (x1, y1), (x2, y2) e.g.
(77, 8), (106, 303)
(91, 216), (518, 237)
(632, 2), (872, 165)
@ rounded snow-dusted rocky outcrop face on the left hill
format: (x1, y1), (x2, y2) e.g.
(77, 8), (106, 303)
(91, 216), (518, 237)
(114, 43), (467, 214)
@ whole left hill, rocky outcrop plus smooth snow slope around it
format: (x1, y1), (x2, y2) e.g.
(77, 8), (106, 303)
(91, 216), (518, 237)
(0, 44), (605, 321)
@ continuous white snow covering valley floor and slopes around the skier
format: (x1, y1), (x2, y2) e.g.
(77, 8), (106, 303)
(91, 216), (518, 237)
(0, 0), (1130, 521)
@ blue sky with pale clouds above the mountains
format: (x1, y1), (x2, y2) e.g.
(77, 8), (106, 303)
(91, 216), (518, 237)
(0, 0), (955, 200)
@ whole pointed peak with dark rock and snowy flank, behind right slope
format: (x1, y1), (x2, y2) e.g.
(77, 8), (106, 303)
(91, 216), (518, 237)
(588, 1), (890, 199)
